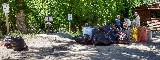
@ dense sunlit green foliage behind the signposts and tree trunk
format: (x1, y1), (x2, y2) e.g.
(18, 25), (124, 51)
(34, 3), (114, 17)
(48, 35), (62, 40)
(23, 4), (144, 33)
(0, 0), (158, 34)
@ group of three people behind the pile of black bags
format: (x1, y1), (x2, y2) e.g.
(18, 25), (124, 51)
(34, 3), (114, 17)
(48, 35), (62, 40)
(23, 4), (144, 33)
(115, 12), (140, 30)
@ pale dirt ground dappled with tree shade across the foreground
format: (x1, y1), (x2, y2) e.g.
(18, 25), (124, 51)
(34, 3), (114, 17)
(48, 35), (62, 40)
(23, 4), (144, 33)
(0, 34), (160, 60)
